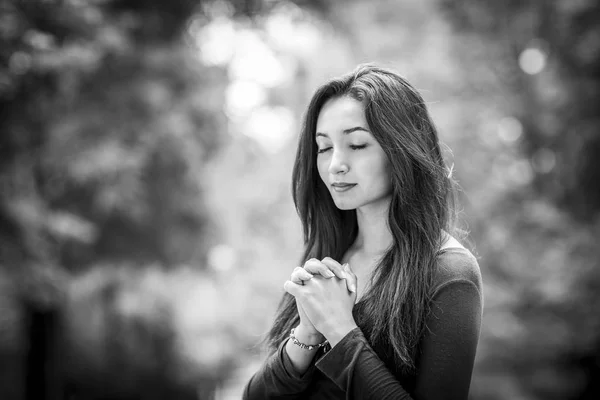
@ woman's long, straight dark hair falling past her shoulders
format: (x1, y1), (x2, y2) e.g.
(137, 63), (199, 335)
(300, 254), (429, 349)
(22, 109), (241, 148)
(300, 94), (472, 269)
(268, 64), (455, 372)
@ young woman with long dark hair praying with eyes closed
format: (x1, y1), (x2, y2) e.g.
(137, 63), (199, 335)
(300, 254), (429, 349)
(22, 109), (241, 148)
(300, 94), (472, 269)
(244, 65), (483, 400)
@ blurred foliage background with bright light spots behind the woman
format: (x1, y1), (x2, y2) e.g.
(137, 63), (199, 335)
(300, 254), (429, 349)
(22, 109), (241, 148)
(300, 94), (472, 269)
(0, 0), (600, 400)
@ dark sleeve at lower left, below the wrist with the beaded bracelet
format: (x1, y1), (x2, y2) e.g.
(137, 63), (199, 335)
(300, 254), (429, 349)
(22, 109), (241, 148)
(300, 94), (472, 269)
(243, 339), (318, 400)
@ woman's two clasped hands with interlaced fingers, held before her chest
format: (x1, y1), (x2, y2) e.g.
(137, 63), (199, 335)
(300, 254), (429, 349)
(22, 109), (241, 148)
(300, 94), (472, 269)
(283, 257), (357, 345)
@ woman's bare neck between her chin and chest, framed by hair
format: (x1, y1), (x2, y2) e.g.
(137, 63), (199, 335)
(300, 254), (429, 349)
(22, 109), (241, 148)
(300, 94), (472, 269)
(352, 199), (393, 255)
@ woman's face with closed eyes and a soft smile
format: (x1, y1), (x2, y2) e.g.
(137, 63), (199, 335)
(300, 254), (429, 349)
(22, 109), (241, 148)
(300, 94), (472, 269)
(315, 96), (392, 211)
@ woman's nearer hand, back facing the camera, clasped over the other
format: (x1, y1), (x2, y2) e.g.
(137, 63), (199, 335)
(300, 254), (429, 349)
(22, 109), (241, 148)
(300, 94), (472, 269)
(283, 265), (357, 346)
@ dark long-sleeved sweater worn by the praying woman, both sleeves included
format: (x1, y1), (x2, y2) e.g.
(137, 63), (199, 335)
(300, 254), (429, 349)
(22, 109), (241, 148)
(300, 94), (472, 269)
(244, 248), (483, 400)
